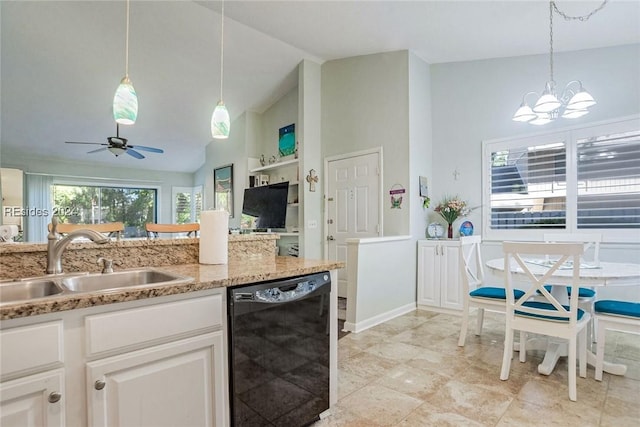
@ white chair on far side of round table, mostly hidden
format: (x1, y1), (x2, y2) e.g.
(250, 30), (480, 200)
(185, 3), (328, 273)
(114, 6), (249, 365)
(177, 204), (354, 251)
(543, 233), (602, 342)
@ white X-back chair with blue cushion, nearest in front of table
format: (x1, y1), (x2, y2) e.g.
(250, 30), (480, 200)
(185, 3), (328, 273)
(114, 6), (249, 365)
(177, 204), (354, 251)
(500, 242), (590, 401)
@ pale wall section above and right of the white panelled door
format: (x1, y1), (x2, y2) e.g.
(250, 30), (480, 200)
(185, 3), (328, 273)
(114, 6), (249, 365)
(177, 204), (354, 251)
(322, 51), (417, 236)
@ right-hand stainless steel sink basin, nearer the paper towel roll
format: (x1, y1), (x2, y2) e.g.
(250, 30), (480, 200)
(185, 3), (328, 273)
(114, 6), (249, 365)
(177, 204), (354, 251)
(61, 269), (191, 292)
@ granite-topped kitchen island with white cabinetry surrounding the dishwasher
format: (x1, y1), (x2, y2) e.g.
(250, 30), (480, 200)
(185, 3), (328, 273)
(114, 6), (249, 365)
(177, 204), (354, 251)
(0, 239), (343, 426)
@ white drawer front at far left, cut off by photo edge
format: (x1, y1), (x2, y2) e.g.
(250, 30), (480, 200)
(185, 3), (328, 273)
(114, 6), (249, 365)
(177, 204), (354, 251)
(0, 320), (64, 379)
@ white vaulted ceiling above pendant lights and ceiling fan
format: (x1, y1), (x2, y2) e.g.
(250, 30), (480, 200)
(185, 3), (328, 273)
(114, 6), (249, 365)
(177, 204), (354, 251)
(0, 0), (640, 172)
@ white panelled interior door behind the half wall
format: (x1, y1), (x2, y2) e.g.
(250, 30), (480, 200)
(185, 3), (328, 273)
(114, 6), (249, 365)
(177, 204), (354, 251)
(326, 152), (381, 298)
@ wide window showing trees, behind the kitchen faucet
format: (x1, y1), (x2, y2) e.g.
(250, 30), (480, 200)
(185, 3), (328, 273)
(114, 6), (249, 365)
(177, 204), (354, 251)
(52, 184), (157, 237)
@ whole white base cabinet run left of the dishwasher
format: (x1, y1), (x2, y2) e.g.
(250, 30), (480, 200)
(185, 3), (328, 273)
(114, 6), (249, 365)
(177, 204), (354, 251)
(0, 288), (229, 427)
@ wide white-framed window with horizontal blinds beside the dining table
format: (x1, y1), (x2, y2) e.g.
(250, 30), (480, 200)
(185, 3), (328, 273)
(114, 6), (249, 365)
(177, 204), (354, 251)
(483, 118), (640, 242)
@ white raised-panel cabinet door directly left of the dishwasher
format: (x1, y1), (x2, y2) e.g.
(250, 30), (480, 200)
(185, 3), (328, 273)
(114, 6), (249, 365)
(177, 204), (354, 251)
(87, 331), (228, 427)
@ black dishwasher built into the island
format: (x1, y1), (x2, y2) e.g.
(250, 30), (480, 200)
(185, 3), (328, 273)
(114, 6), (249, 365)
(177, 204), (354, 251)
(227, 272), (331, 427)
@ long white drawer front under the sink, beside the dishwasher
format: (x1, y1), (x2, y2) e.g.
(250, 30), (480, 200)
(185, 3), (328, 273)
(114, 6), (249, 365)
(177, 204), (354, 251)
(85, 294), (224, 356)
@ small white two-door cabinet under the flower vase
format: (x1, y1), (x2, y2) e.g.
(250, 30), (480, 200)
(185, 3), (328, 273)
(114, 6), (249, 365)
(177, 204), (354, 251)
(417, 240), (462, 311)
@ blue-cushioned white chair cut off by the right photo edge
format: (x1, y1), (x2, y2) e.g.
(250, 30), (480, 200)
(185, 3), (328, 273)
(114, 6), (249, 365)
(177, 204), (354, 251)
(594, 300), (640, 381)
